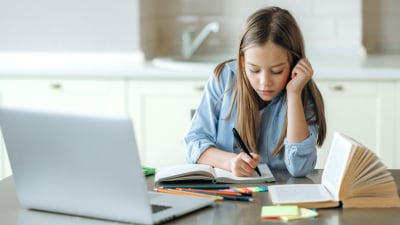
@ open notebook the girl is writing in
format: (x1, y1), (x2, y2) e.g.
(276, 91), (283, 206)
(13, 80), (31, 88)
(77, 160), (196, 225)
(154, 164), (275, 183)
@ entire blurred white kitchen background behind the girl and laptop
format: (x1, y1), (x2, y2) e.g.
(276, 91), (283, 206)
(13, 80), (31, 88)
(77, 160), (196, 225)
(0, 0), (400, 179)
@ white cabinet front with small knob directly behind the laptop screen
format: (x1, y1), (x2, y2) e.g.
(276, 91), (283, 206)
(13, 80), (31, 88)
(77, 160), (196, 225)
(0, 78), (127, 179)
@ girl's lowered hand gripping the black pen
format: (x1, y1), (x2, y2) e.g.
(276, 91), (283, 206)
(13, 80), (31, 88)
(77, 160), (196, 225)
(231, 152), (260, 177)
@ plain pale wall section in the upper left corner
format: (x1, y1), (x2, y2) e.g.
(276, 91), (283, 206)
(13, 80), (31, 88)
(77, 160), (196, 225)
(0, 0), (140, 52)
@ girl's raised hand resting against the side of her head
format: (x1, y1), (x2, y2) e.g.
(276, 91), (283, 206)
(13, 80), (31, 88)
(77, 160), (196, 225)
(286, 58), (314, 95)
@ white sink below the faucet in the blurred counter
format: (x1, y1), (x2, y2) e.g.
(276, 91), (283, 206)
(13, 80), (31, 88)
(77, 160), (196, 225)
(152, 54), (235, 70)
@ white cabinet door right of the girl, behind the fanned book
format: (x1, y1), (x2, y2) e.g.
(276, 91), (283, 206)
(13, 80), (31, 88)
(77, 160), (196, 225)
(317, 81), (395, 168)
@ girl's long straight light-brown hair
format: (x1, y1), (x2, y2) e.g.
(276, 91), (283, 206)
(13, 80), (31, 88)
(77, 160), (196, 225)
(214, 7), (326, 156)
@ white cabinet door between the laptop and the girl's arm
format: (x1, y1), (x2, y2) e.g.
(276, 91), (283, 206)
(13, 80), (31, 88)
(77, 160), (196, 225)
(129, 80), (205, 167)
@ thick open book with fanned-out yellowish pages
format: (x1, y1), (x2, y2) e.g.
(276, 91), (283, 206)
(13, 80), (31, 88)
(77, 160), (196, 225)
(268, 132), (400, 208)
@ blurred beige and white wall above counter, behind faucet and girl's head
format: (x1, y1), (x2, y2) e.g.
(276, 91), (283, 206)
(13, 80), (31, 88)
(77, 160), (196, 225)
(140, 0), (400, 58)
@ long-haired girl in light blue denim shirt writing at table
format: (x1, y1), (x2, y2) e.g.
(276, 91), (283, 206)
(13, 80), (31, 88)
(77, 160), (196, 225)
(184, 7), (326, 177)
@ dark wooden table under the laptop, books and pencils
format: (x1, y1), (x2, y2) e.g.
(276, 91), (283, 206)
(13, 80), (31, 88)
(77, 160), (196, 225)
(0, 170), (400, 225)
